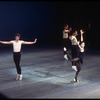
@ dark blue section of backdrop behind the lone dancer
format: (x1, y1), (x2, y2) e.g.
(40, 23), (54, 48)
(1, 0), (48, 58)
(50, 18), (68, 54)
(0, 1), (55, 44)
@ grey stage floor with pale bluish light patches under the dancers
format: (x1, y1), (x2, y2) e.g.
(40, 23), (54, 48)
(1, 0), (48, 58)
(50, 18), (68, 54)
(0, 48), (100, 99)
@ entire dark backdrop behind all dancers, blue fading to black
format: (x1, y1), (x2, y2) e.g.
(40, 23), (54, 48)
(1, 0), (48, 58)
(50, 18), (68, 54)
(0, 1), (100, 49)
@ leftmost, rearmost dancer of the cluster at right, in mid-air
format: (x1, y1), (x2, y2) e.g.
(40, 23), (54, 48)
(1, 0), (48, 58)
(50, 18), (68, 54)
(63, 24), (72, 60)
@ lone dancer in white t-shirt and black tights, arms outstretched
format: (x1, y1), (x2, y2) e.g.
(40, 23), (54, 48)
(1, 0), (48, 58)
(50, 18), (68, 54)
(0, 33), (37, 80)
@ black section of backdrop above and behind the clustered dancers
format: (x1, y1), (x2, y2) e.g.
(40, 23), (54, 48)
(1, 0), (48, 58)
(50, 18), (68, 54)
(56, 1), (100, 49)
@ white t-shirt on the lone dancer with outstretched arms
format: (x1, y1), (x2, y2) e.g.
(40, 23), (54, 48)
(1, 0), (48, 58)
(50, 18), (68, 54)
(10, 40), (24, 52)
